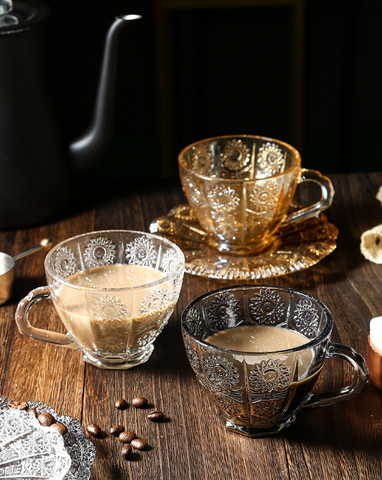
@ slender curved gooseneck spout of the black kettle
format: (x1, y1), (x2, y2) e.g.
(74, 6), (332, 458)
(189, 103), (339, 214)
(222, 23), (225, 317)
(69, 15), (141, 171)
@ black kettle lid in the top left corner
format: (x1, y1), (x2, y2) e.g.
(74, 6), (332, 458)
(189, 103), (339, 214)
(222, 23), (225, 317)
(0, 0), (51, 35)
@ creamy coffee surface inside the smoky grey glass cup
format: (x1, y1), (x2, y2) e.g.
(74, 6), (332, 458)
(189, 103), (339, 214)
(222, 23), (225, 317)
(206, 325), (313, 379)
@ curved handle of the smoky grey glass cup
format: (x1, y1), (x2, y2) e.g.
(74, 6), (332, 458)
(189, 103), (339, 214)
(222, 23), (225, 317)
(302, 343), (369, 409)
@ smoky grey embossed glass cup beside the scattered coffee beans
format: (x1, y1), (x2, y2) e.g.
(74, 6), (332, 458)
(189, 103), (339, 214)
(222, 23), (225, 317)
(181, 285), (369, 437)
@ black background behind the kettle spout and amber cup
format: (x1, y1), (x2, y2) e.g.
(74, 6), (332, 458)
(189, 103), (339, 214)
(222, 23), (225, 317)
(40, 0), (382, 179)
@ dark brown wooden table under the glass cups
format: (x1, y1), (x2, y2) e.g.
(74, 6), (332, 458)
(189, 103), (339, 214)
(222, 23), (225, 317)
(0, 173), (382, 480)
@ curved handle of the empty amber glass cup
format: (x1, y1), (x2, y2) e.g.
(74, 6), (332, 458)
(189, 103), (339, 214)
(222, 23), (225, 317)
(282, 168), (334, 227)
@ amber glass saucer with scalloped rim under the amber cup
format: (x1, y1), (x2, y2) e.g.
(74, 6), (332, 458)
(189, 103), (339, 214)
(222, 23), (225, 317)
(150, 204), (338, 280)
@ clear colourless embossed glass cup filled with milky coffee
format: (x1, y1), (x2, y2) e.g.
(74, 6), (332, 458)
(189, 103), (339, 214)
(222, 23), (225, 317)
(15, 230), (185, 369)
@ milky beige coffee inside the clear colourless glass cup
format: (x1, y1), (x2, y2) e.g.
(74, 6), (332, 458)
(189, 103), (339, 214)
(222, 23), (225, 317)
(55, 265), (174, 354)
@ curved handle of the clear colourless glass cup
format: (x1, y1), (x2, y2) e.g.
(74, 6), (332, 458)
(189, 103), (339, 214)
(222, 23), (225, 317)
(15, 286), (78, 348)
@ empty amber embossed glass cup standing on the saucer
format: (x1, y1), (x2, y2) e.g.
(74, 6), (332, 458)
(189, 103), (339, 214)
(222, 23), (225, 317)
(178, 135), (334, 255)
